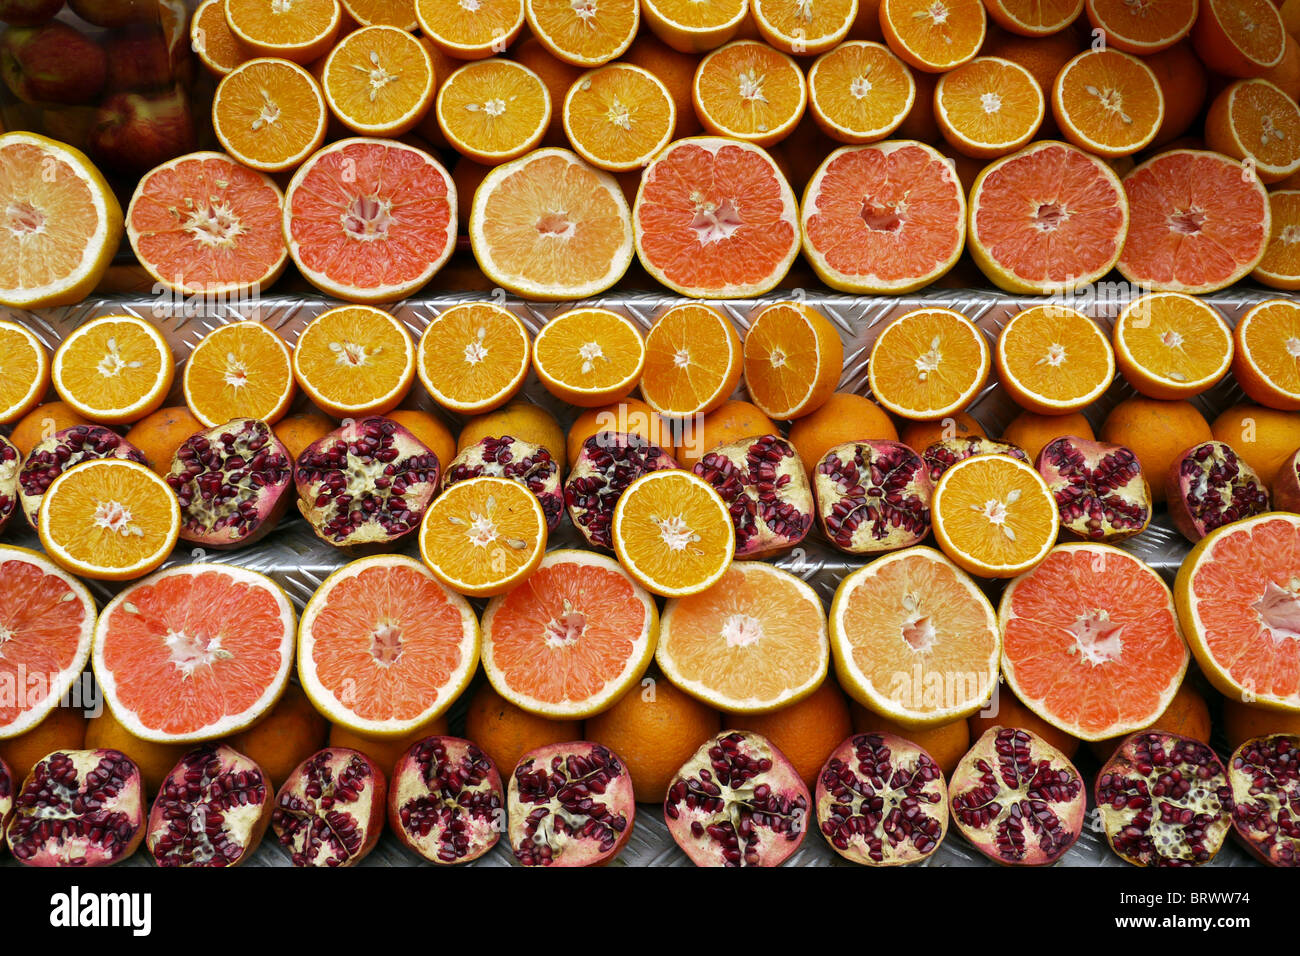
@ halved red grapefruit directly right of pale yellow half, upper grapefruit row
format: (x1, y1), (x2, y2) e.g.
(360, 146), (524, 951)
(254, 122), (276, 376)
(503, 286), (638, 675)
(633, 137), (800, 298)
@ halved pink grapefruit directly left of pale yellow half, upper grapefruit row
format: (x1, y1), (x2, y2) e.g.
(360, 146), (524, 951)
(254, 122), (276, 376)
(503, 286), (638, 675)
(283, 137), (456, 302)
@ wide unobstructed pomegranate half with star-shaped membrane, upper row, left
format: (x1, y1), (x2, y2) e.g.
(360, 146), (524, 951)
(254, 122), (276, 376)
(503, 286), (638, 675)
(295, 418), (442, 548)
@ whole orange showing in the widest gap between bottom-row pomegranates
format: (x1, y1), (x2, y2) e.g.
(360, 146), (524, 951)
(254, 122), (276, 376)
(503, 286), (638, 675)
(584, 679), (723, 804)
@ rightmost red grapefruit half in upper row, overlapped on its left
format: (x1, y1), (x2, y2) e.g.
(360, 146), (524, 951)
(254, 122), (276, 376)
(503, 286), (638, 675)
(1119, 150), (1271, 293)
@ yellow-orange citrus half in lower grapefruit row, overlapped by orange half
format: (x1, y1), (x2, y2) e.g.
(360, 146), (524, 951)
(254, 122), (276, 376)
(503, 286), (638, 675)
(655, 561), (831, 714)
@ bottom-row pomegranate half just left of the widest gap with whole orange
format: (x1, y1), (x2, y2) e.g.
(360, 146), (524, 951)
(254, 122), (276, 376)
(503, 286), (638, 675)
(506, 740), (637, 866)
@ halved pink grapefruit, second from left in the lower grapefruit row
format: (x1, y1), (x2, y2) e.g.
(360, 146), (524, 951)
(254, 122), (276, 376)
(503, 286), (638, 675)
(93, 564), (296, 744)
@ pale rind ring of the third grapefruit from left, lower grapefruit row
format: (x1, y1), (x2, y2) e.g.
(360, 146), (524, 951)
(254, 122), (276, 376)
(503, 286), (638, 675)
(298, 554), (482, 739)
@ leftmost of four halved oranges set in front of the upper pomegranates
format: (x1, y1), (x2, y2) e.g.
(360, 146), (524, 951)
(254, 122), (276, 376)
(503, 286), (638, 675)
(36, 458), (181, 581)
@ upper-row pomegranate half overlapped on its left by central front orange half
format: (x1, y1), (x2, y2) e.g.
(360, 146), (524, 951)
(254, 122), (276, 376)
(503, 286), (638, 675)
(694, 434), (813, 558)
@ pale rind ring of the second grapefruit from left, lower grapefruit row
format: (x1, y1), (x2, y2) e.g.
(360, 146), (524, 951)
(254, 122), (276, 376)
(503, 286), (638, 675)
(91, 563), (296, 744)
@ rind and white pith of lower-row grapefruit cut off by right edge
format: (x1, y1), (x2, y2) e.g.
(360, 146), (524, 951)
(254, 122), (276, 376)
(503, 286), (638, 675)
(1174, 511), (1300, 713)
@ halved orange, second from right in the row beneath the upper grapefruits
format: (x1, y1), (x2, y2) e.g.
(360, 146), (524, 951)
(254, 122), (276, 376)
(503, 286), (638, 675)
(1112, 293), (1232, 399)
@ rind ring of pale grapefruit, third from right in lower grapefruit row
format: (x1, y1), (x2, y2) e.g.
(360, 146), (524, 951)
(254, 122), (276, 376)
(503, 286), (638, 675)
(829, 545), (1002, 728)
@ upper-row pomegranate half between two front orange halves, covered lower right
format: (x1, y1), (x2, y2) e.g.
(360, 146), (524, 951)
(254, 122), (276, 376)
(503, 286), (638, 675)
(564, 432), (677, 551)
